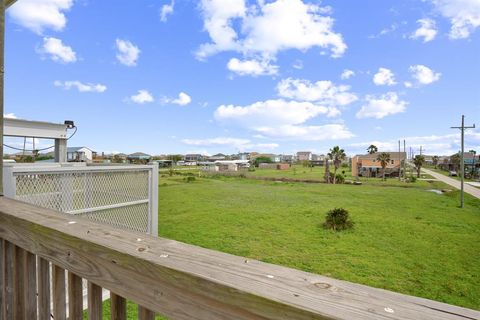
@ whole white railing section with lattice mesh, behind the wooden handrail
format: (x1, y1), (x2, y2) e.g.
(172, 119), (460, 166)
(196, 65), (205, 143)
(3, 163), (158, 236)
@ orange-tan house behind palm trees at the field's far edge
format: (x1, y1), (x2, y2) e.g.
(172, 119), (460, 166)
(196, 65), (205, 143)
(351, 152), (407, 177)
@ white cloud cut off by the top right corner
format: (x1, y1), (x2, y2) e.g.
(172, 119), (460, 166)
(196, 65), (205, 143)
(430, 0), (480, 39)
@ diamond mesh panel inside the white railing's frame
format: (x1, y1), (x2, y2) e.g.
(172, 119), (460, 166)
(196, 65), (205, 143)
(14, 167), (149, 232)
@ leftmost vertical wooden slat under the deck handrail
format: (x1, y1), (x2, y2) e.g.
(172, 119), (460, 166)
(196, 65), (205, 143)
(2, 240), (14, 320)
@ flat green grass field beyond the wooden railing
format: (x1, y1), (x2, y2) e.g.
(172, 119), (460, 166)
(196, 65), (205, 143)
(158, 175), (480, 309)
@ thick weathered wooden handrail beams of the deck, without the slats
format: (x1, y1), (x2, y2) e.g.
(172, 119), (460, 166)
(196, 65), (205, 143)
(0, 199), (480, 320)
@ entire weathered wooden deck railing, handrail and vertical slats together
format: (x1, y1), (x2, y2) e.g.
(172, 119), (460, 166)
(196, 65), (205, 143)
(0, 198), (480, 320)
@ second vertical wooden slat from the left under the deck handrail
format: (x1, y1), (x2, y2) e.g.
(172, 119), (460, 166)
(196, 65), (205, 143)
(13, 246), (25, 320)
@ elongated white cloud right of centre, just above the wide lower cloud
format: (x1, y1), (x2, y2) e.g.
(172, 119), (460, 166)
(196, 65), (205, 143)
(277, 78), (357, 106)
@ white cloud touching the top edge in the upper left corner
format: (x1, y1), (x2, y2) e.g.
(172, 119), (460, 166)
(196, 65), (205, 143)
(7, 0), (73, 34)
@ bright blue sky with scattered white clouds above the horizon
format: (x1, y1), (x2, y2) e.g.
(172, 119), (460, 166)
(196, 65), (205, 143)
(5, 0), (480, 154)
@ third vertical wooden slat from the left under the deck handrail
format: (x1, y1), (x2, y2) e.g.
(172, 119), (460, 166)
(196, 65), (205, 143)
(25, 251), (37, 320)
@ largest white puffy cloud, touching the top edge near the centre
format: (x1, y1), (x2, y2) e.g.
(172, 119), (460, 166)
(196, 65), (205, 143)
(197, 0), (347, 59)
